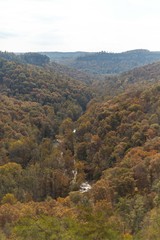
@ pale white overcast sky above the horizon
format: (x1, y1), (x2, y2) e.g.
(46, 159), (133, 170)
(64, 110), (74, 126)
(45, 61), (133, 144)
(0, 0), (160, 52)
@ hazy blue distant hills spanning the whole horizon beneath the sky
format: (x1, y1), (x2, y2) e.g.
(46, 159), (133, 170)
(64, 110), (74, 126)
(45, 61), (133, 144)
(14, 49), (160, 75)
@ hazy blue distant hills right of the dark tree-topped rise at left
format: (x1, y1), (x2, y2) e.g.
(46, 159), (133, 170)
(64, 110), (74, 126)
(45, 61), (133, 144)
(44, 49), (160, 75)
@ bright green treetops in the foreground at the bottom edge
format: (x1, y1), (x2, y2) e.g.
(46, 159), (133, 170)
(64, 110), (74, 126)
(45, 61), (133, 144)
(14, 212), (122, 240)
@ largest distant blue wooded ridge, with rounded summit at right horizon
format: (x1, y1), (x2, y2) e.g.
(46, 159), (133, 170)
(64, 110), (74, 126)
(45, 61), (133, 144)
(69, 50), (160, 74)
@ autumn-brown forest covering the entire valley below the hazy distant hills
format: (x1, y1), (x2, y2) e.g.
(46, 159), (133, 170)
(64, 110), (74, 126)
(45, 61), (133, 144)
(0, 53), (160, 240)
